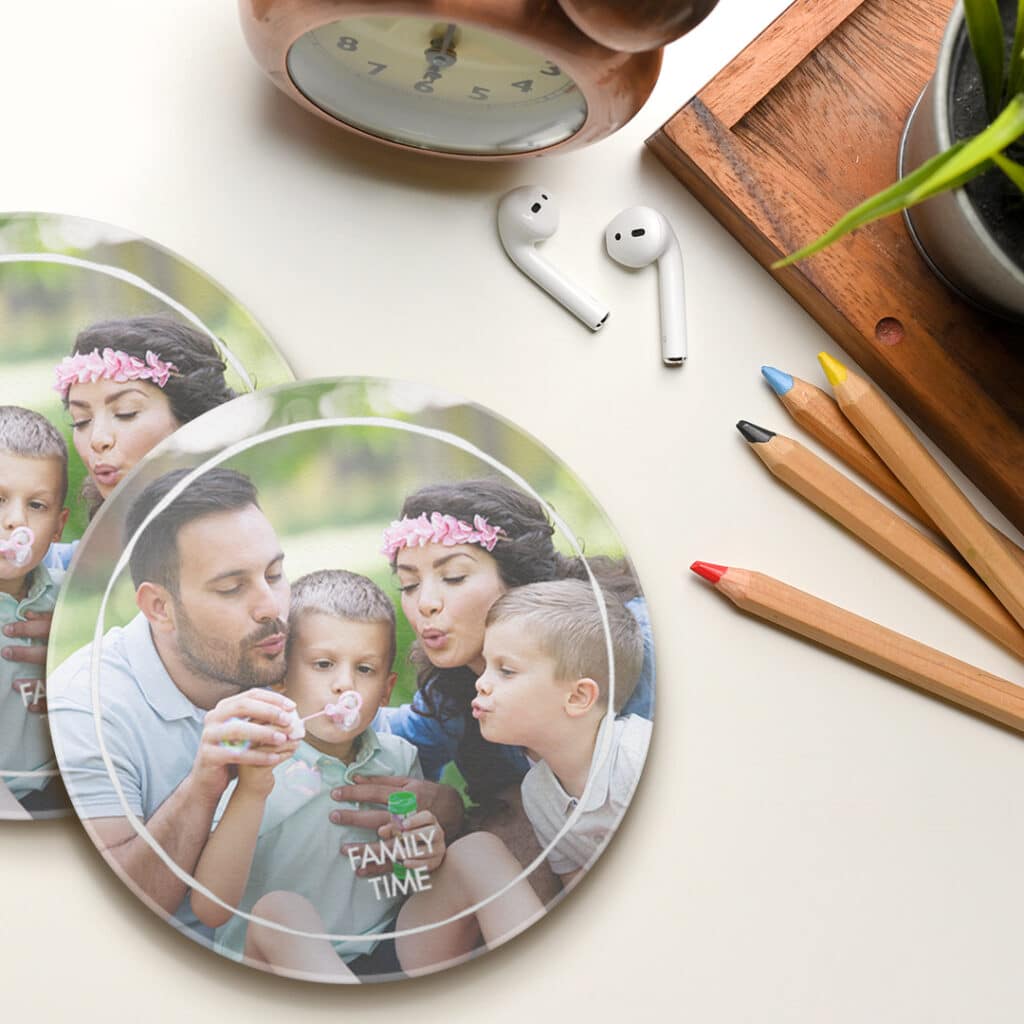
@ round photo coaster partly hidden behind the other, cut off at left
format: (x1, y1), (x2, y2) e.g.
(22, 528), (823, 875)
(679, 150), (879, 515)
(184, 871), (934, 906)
(0, 213), (294, 820)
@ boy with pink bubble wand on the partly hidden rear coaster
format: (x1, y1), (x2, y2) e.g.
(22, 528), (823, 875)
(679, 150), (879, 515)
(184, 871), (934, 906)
(0, 406), (68, 818)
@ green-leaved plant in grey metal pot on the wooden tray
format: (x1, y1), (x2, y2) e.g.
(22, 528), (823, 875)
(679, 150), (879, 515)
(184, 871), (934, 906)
(773, 0), (1024, 321)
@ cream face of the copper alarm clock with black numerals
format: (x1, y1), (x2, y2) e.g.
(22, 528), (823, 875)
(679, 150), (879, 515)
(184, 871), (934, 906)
(288, 16), (587, 156)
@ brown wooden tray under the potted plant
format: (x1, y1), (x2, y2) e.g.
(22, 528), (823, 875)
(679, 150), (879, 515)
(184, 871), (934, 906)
(647, 0), (1024, 529)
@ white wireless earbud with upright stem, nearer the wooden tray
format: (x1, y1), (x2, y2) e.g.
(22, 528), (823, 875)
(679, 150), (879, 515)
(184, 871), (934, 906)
(604, 206), (686, 367)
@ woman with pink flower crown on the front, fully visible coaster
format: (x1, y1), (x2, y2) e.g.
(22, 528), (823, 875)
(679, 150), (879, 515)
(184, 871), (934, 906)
(344, 479), (654, 896)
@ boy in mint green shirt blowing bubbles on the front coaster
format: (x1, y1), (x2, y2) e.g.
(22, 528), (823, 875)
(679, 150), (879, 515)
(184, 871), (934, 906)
(191, 570), (542, 982)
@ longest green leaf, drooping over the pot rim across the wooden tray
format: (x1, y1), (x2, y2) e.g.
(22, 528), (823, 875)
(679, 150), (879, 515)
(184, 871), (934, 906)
(772, 94), (1024, 270)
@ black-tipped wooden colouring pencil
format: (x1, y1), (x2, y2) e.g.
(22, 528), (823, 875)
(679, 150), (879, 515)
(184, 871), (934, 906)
(736, 420), (1024, 658)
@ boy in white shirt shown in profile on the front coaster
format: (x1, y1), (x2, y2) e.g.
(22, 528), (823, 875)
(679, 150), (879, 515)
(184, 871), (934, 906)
(473, 580), (651, 885)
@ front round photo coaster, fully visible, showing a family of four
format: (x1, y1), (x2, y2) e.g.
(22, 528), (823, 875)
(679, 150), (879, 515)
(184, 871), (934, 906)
(48, 378), (654, 983)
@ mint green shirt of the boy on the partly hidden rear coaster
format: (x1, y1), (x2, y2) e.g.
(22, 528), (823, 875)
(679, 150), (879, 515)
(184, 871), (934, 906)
(0, 565), (63, 800)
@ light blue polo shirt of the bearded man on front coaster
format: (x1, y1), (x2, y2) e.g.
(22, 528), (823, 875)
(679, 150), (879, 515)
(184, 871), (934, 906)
(47, 614), (211, 936)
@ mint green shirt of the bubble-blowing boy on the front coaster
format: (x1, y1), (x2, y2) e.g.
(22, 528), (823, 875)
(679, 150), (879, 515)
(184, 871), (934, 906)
(214, 729), (423, 961)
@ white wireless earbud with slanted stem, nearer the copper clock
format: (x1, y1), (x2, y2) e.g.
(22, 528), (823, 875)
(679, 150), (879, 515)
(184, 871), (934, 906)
(498, 185), (608, 331)
